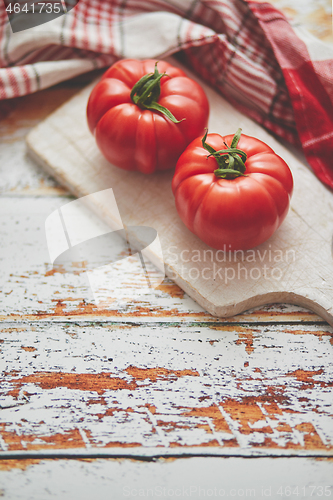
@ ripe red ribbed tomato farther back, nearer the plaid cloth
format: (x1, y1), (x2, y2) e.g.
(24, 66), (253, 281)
(87, 59), (209, 174)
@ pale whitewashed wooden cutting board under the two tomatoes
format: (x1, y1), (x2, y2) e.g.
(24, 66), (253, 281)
(27, 60), (333, 325)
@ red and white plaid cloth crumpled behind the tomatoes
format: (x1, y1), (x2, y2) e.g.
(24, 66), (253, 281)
(0, 0), (333, 188)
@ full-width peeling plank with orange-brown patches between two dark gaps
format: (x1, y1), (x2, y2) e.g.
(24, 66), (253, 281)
(0, 322), (333, 454)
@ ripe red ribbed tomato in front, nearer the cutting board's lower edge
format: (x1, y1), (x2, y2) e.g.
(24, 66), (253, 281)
(172, 129), (293, 250)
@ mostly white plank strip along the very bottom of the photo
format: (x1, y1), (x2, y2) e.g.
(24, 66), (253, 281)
(0, 458), (333, 500)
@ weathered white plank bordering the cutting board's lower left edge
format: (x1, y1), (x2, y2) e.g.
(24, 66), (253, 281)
(0, 195), (323, 322)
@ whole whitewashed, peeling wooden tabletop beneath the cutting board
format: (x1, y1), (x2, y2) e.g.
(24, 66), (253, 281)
(0, 0), (333, 500)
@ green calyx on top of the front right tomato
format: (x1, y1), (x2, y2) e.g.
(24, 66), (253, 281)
(201, 128), (247, 179)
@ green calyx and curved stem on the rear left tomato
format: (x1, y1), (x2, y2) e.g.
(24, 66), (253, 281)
(131, 62), (183, 123)
